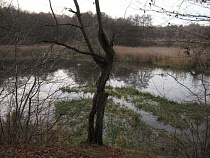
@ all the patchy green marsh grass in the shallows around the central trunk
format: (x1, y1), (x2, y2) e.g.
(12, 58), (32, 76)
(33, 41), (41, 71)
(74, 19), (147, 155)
(56, 85), (209, 157)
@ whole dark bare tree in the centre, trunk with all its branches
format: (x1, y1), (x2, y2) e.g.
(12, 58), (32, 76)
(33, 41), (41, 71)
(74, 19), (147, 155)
(44, 0), (115, 145)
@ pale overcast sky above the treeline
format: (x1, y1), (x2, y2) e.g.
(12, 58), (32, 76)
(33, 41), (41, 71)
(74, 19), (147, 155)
(5, 0), (210, 25)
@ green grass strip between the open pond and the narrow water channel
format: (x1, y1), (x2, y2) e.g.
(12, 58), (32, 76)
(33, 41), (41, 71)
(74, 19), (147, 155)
(62, 85), (205, 129)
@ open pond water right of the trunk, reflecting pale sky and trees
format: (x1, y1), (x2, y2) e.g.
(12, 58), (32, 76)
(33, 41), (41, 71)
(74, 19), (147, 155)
(109, 63), (210, 103)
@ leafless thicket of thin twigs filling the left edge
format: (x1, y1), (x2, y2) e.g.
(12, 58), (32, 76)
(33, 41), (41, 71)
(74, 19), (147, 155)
(0, 2), (65, 144)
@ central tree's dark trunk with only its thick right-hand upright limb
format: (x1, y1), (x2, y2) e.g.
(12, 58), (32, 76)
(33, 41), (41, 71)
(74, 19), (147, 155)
(87, 0), (115, 145)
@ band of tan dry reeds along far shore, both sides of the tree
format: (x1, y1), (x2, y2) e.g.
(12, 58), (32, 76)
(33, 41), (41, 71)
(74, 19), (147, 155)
(0, 44), (210, 70)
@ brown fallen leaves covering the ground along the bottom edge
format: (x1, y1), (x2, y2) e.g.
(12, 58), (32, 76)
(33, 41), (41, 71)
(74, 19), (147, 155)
(0, 142), (149, 158)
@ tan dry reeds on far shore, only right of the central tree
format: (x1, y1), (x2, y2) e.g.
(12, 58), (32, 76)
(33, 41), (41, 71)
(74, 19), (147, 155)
(114, 46), (210, 67)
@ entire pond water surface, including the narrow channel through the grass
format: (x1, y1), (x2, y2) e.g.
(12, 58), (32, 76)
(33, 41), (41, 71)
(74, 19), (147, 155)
(0, 60), (210, 132)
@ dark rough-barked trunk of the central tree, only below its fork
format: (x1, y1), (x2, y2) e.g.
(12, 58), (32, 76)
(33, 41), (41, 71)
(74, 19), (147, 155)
(87, 62), (112, 145)
